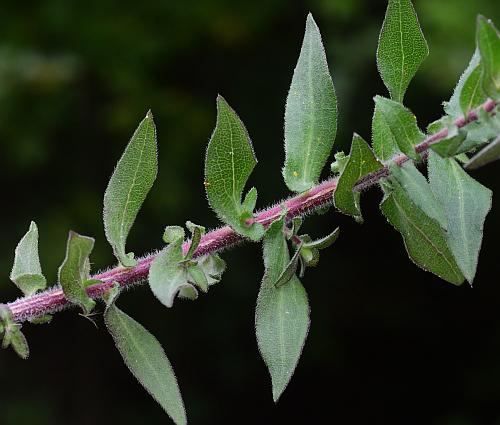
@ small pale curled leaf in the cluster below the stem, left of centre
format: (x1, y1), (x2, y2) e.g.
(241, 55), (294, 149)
(149, 237), (197, 307)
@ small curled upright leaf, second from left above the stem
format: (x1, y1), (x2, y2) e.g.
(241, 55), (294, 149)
(58, 231), (95, 314)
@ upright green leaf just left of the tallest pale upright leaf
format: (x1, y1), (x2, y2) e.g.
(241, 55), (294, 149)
(205, 96), (264, 240)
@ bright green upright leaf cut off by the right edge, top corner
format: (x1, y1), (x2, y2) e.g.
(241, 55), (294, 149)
(476, 16), (500, 100)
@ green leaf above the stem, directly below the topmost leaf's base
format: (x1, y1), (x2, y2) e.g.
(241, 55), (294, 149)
(375, 96), (425, 160)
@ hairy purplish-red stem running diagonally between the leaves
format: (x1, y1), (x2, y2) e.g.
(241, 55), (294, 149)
(7, 99), (496, 323)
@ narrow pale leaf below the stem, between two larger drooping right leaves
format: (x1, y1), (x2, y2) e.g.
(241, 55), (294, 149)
(391, 162), (448, 230)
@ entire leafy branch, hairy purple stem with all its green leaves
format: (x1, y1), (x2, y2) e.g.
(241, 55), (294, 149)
(0, 0), (500, 424)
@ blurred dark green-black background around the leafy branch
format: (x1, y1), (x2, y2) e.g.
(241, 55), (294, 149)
(0, 0), (500, 425)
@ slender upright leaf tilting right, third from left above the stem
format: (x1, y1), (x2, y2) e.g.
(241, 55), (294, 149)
(104, 111), (158, 267)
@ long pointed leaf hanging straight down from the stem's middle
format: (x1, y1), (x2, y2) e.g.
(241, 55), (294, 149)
(255, 218), (309, 401)
